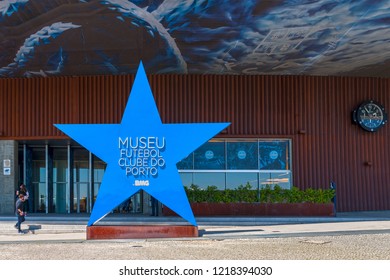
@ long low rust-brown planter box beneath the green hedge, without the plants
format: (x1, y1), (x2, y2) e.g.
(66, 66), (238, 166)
(163, 202), (335, 217)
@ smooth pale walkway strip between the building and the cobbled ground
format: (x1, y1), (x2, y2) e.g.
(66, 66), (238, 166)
(0, 211), (390, 243)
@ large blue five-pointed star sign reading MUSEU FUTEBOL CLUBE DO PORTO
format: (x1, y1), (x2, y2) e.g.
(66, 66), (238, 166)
(55, 63), (229, 226)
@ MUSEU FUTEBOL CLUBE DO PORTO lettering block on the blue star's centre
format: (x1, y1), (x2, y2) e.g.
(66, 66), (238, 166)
(118, 136), (166, 177)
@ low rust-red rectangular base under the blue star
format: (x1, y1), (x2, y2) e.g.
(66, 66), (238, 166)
(87, 225), (199, 240)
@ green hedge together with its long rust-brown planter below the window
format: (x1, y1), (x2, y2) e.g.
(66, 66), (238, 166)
(164, 183), (334, 216)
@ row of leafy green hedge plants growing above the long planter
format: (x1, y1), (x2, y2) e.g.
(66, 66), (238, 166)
(185, 183), (334, 203)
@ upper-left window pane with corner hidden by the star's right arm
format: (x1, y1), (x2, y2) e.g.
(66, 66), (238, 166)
(194, 142), (226, 170)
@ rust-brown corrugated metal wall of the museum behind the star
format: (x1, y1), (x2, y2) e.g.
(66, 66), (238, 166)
(0, 75), (390, 211)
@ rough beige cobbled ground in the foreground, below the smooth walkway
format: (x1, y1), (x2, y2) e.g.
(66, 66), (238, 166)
(0, 233), (390, 260)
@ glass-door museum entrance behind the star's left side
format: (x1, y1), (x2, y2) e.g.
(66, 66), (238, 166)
(19, 143), (143, 214)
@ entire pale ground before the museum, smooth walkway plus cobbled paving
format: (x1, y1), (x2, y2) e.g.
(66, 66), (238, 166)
(0, 211), (390, 260)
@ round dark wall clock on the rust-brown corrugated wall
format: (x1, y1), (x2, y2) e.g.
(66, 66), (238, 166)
(353, 100), (387, 132)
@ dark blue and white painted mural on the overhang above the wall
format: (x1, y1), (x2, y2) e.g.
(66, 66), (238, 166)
(0, 0), (390, 77)
